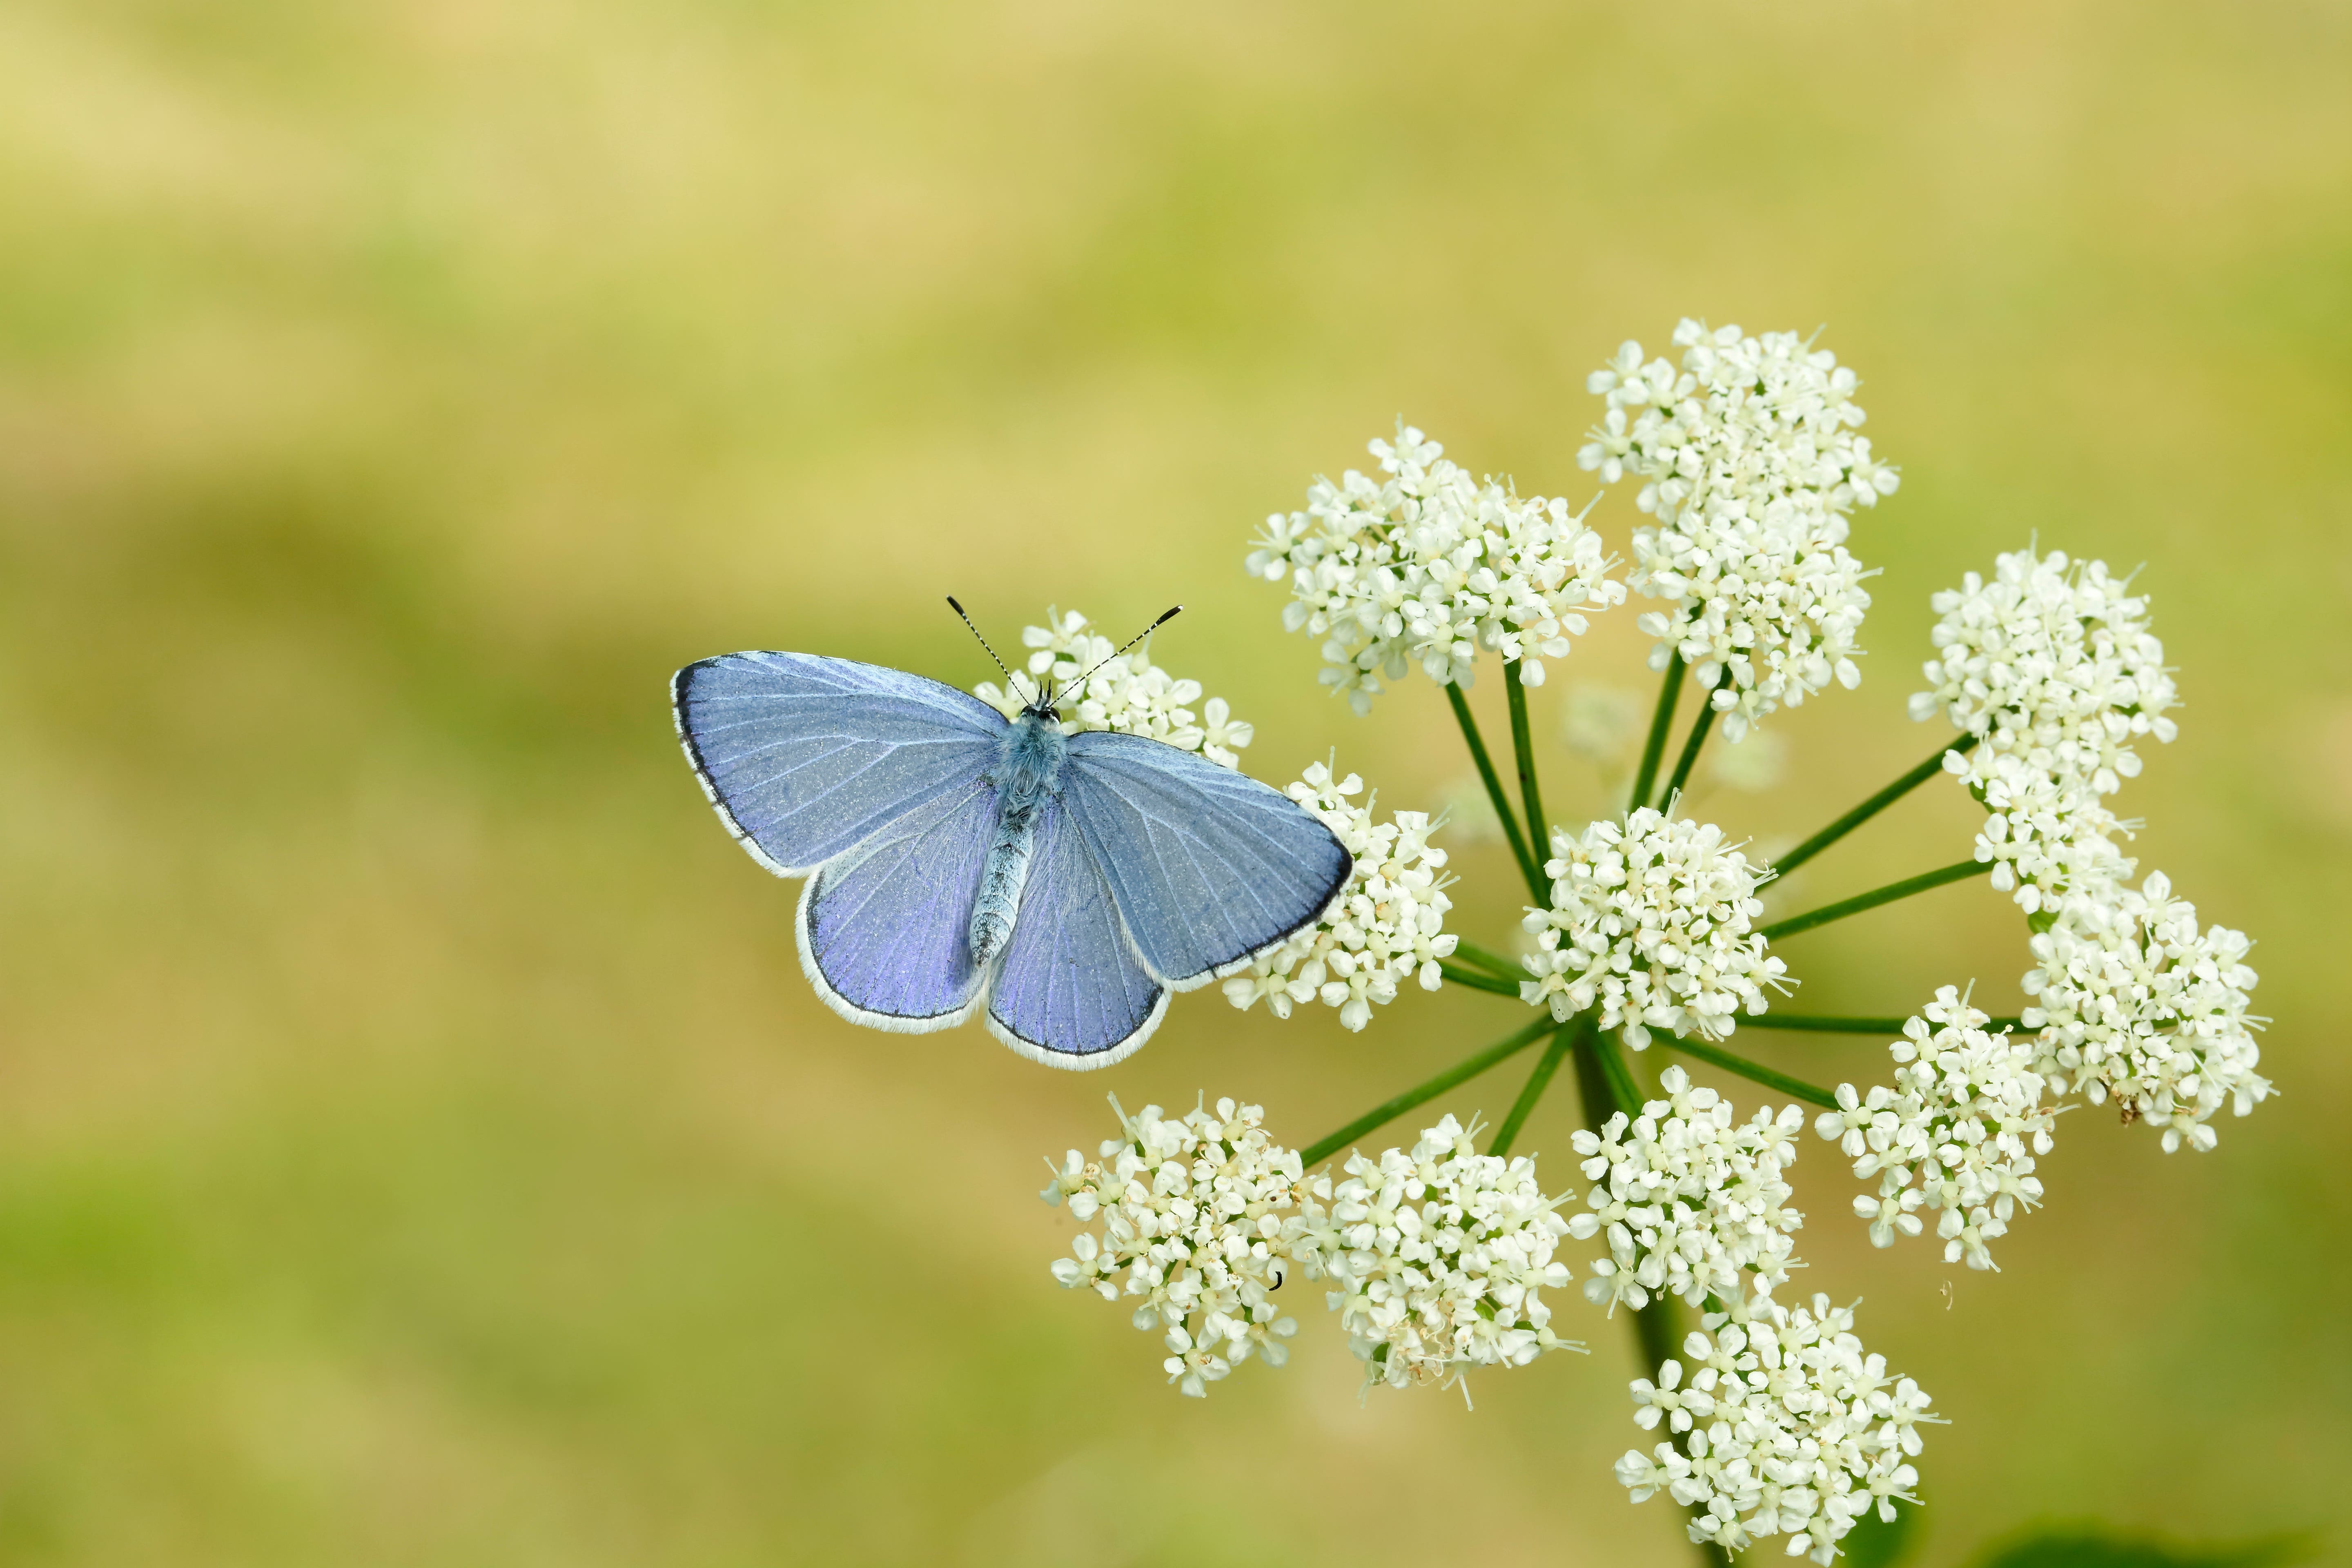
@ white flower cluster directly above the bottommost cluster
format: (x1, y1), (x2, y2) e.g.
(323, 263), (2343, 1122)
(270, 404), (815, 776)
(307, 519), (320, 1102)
(1569, 1067), (1804, 1316)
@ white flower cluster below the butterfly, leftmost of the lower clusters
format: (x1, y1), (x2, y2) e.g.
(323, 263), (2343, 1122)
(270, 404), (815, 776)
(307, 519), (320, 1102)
(1040, 1100), (1301, 1396)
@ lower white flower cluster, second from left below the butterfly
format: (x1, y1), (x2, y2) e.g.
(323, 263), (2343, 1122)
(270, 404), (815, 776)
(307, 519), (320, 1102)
(1294, 1117), (1583, 1396)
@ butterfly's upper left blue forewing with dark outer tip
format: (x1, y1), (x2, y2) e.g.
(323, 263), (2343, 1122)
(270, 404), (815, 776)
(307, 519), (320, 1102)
(670, 653), (1004, 877)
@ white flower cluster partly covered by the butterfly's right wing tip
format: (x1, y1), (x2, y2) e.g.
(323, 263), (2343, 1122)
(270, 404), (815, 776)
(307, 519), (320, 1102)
(1225, 762), (1461, 1030)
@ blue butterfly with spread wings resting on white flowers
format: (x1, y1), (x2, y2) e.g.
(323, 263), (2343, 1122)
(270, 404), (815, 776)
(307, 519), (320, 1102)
(670, 599), (1355, 1067)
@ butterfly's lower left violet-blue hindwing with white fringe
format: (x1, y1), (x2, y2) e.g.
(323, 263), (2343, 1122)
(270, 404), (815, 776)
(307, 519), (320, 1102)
(800, 780), (997, 1034)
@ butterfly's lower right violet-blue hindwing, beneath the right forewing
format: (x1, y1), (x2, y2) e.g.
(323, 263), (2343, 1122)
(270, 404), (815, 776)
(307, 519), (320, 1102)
(988, 806), (1169, 1067)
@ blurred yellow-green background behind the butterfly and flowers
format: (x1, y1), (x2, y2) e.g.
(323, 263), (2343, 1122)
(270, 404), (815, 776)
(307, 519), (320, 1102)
(0, 0), (2352, 1568)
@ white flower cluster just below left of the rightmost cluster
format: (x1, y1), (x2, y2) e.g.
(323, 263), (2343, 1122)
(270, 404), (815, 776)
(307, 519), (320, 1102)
(1813, 985), (2058, 1270)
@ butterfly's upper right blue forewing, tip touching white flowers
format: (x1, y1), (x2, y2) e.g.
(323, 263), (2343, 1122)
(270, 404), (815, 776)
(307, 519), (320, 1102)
(1058, 731), (1355, 990)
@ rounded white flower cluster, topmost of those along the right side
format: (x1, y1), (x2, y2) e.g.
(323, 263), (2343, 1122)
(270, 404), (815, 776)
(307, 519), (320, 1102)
(1910, 550), (2178, 795)
